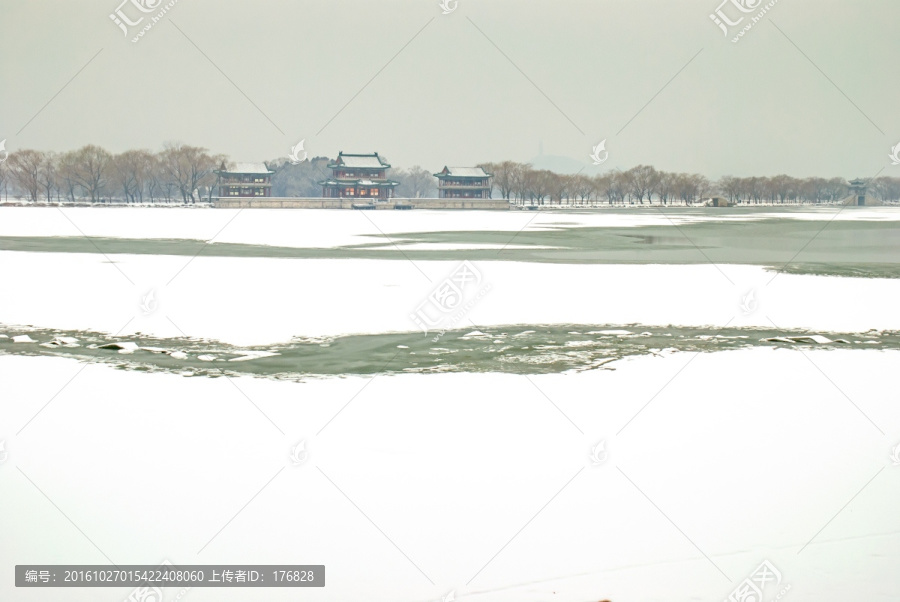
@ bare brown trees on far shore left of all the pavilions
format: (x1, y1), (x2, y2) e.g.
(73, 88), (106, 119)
(0, 143), (228, 203)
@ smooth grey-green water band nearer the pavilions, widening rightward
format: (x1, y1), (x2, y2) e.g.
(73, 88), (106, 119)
(0, 218), (900, 278)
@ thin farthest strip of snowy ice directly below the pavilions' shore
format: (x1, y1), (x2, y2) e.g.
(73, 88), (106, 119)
(0, 207), (900, 247)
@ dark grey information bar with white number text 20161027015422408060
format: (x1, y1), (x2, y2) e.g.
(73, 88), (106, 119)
(16, 562), (325, 588)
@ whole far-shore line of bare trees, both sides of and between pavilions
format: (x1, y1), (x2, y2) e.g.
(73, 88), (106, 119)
(0, 143), (900, 205)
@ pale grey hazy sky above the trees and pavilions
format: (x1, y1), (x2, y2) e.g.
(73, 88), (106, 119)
(0, 0), (900, 177)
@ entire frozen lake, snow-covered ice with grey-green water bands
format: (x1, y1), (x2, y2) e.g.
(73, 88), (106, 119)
(0, 208), (900, 602)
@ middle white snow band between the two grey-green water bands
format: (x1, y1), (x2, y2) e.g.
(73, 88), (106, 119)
(0, 252), (900, 345)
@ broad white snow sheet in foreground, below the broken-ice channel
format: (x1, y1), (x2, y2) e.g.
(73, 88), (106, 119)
(0, 349), (900, 602)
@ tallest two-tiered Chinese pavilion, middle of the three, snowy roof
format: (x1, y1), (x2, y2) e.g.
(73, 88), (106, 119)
(319, 151), (399, 200)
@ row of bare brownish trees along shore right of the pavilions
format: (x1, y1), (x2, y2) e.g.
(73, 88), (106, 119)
(481, 161), (900, 205)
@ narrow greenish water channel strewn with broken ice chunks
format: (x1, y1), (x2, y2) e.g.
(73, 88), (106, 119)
(0, 325), (900, 380)
